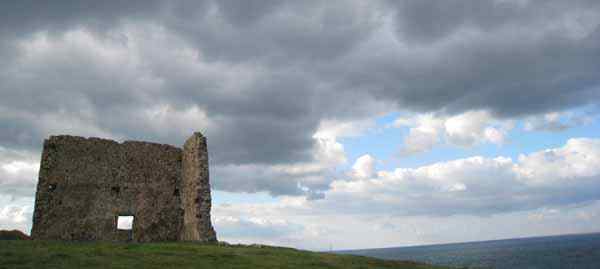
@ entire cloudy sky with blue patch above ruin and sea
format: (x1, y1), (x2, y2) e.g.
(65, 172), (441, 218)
(0, 0), (600, 250)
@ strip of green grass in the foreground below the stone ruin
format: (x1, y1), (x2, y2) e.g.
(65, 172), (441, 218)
(0, 240), (448, 269)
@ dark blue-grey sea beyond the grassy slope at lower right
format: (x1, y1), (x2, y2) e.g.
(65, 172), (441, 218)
(336, 233), (600, 269)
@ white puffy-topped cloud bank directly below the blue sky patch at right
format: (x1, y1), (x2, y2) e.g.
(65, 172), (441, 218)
(322, 138), (600, 215)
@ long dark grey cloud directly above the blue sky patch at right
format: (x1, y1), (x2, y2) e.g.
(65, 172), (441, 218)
(338, 30), (600, 117)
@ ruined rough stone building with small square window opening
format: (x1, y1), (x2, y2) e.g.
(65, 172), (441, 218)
(31, 133), (217, 242)
